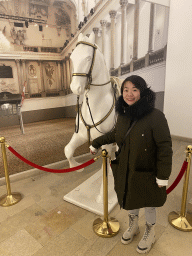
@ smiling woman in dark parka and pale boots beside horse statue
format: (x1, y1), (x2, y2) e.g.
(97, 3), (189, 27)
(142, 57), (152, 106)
(90, 75), (172, 253)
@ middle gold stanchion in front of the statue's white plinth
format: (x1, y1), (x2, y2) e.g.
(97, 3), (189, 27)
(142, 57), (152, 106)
(93, 149), (120, 237)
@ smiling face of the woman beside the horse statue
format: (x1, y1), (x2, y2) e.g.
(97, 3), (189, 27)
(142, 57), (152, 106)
(123, 81), (140, 105)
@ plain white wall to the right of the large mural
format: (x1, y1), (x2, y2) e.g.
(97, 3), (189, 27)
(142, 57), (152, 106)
(164, 0), (192, 138)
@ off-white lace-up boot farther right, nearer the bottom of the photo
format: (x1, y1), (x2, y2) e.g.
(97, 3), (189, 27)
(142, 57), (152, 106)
(137, 222), (155, 253)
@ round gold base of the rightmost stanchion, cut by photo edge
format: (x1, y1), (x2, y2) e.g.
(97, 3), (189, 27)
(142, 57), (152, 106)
(168, 212), (192, 231)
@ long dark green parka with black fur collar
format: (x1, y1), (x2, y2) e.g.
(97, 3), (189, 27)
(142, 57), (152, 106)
(92, 89), (172, 210)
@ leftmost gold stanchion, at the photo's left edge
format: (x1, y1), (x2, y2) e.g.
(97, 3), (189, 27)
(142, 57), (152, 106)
(0, 137), (22, 206)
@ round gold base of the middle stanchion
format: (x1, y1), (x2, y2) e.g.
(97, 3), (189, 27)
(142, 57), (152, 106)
(93, 218), (120, 238)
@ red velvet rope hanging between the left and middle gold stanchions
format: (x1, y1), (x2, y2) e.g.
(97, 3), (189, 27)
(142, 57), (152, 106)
(8, 146), (95, 173)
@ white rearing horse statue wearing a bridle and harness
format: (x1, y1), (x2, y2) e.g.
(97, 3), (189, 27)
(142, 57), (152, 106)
(64, 33), (120, 202)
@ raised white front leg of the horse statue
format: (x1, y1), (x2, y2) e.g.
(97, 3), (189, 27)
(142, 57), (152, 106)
(64, 133), (87, 171)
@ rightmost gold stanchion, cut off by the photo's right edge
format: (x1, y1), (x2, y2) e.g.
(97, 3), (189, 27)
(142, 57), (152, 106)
(168, 145), (192, 231)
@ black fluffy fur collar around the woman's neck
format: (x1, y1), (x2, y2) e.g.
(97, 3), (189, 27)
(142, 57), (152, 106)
(115, 88), (155, 120)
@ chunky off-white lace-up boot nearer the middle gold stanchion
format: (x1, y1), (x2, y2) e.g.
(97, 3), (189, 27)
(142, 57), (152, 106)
(121, 214), (140, 244)
